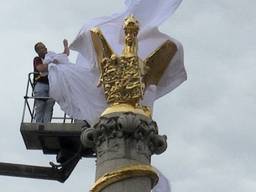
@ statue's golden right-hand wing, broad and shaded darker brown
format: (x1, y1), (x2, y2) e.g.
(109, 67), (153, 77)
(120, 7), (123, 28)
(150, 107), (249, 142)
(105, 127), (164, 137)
(143, 40), (177, 86)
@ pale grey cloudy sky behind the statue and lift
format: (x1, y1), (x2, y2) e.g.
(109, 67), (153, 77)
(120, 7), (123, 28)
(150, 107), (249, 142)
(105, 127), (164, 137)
(0, 0), (256, 192)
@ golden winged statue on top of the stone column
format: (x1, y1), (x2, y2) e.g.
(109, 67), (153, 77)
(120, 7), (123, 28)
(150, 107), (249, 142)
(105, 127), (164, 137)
(91, 16), (177, 117)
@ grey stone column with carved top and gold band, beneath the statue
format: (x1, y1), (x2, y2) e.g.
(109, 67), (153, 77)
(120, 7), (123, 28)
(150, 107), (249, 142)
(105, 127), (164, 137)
(81, 113), (167, 192)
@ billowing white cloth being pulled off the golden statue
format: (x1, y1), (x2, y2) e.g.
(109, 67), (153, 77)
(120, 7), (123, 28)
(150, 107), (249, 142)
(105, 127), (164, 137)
(49, 0), (186, 123)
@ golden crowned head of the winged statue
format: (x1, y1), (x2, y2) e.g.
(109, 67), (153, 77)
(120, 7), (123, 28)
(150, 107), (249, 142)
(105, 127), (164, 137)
(124, 15), (139, 46)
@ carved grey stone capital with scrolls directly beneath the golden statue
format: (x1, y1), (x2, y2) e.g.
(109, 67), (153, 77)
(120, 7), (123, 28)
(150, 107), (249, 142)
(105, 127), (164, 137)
(81, 113), (167, 156)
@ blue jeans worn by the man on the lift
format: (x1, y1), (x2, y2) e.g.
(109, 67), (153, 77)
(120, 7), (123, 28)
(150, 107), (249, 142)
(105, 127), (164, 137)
(34, 82), (55, 123)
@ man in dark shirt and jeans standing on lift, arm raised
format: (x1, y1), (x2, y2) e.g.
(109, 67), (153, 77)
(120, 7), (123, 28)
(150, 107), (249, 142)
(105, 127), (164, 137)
(33, 39), (69, 123)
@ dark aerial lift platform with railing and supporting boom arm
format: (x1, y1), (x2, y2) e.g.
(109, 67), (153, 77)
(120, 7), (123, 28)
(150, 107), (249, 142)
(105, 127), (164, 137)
(0, 72), (96, 182)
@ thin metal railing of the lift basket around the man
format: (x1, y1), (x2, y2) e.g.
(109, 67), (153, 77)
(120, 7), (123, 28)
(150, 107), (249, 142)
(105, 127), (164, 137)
(22, 72), (74, 123)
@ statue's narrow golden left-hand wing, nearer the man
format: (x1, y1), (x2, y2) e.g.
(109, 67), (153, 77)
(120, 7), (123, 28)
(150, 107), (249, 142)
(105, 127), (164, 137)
(90, 27), (114, 66)
